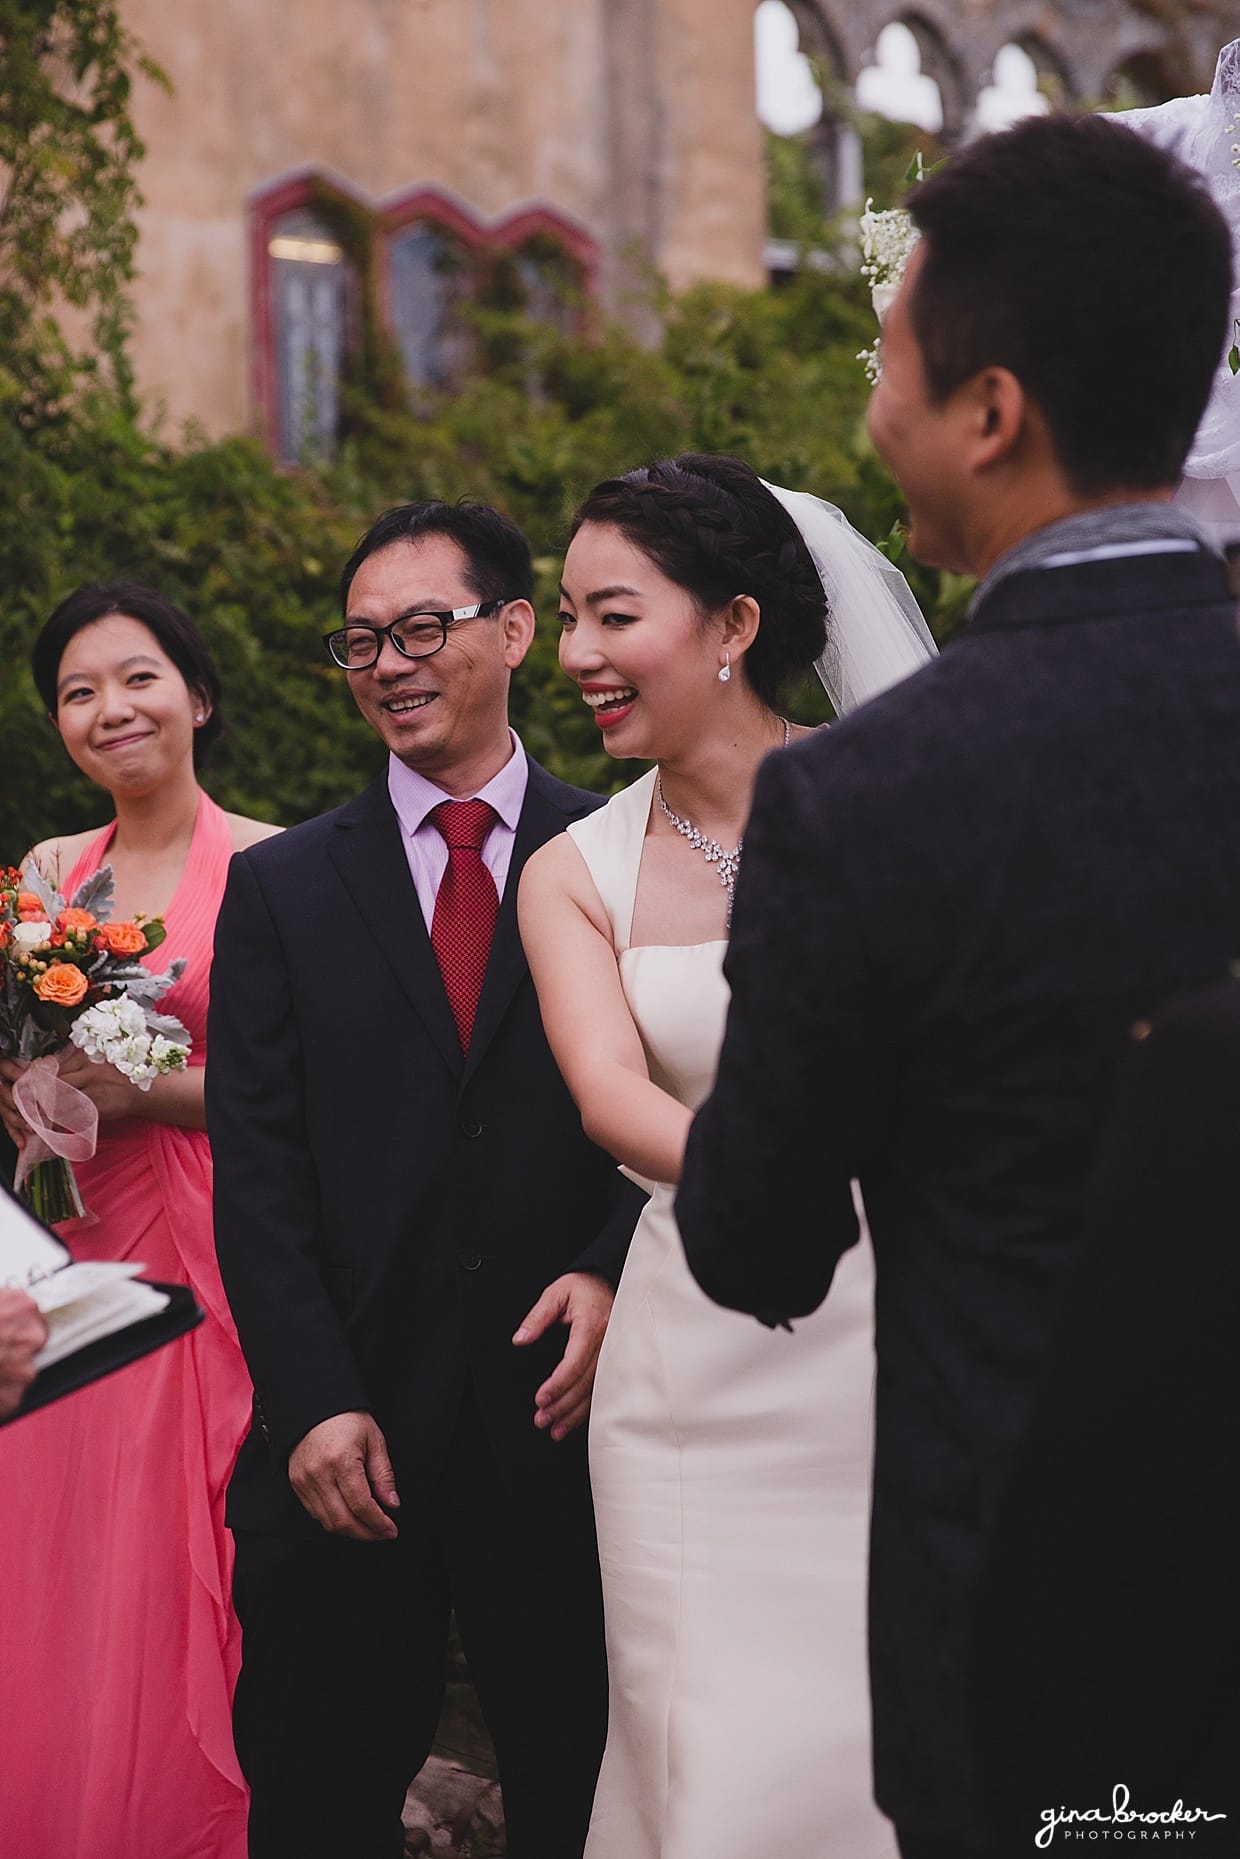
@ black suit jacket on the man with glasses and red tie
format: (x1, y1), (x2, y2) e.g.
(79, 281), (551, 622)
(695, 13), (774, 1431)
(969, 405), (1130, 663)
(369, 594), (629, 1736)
(206, 762), (645, 1532)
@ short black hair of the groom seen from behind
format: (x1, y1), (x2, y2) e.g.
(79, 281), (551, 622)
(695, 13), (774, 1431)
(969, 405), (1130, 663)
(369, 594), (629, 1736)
(907, 112), (1233, 496)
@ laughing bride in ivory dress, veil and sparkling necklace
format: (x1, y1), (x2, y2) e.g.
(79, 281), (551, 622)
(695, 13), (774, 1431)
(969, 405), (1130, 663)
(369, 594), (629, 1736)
(519, 454), (933, 1859)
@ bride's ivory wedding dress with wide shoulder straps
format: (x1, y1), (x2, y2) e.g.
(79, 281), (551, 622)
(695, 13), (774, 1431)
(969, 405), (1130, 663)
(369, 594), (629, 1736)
(569, 771), (896, 1859)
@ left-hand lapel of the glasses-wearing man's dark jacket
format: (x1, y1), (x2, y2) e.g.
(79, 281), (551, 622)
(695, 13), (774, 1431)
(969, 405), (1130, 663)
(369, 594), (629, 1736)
(327, 777), (462, 1078)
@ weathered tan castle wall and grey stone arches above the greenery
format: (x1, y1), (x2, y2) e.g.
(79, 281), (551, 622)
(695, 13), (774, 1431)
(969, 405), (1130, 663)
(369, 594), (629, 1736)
(121, 0), (1236, 433)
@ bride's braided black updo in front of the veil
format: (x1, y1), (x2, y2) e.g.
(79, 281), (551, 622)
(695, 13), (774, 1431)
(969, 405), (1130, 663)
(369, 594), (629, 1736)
(573, 452), (827, 710)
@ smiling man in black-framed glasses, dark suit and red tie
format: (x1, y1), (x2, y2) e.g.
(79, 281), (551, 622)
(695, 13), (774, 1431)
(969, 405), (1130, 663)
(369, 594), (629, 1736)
(206, 502), (643, 1859)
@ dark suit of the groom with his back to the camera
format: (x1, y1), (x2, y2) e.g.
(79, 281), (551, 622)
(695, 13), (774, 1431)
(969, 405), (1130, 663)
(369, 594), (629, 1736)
(677, 552), (1240, 1837)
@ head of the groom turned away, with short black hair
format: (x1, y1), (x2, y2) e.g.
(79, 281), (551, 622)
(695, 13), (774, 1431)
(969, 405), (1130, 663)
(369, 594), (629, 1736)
(870, 115), (1233, 574)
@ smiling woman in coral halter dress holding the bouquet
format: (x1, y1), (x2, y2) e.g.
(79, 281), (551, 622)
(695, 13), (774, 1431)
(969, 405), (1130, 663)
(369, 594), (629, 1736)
(0, 586), (271, 1859)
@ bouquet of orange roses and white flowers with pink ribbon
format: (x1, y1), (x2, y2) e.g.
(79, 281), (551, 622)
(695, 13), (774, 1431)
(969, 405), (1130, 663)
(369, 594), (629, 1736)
(0, 859), (190, 1223)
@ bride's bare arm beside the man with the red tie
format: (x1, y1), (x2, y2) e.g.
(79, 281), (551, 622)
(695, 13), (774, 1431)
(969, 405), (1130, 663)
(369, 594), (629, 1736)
(517, 833), (692, 1182)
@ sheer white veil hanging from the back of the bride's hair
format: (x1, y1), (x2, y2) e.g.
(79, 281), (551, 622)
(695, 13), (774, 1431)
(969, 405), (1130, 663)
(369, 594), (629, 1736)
(762, 478), (939, 716)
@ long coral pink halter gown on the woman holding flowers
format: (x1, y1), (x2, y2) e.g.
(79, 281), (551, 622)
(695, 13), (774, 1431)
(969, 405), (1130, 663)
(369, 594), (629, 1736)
(0, 794), (249, 1859)
